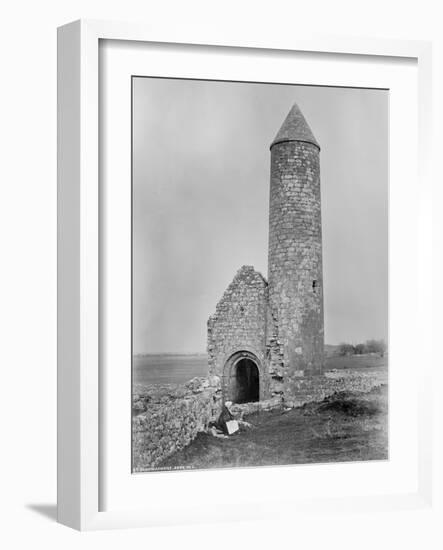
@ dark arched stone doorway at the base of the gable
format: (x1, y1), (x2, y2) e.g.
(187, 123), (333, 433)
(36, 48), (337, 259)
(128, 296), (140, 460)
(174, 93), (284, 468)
(223, 351), (260, 403)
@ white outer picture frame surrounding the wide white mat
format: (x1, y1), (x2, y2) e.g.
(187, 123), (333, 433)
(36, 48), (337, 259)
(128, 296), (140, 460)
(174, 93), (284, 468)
(57, 21), (433, 530)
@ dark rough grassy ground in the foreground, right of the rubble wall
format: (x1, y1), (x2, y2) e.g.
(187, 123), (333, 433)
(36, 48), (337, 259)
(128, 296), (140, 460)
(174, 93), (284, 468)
(159, 386), (388, 469)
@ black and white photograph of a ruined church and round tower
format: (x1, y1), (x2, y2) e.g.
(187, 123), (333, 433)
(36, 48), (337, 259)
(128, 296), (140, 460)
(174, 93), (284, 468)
(131, 76), (389, 473)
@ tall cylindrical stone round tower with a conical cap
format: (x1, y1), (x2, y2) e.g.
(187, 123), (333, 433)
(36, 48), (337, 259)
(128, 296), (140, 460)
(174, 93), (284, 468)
(267, 105), (324, 384)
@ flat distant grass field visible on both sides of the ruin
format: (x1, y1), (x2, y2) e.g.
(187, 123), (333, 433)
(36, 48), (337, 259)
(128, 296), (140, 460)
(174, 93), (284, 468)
(133, 354), (388, 386)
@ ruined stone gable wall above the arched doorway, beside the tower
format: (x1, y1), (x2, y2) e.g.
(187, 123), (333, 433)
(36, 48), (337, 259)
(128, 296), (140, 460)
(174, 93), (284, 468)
(208, 266), (268, 388)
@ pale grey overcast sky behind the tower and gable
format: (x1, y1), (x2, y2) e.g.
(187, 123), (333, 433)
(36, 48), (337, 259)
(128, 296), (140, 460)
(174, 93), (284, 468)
(133, 78), (389, 353)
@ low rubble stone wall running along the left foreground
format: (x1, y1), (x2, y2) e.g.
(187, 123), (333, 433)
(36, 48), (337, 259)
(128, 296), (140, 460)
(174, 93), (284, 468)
(132, 377), (221, 472)
